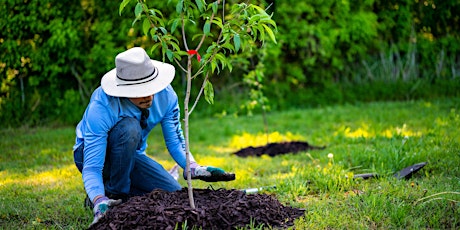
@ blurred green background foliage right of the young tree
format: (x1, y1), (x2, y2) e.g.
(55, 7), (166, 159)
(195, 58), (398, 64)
(258, 0), (460, 109)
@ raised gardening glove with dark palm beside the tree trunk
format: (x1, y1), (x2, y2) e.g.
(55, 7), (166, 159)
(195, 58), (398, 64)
(184, 162), (235, 182)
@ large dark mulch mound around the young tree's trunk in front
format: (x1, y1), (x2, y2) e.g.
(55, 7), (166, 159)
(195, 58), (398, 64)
(89, 188), (305, 230)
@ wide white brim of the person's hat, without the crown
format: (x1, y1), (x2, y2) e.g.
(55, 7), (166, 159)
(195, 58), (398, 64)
(101, 60), (176, 98)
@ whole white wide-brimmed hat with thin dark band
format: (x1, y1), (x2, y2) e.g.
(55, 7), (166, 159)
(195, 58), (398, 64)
(101, 47), (176, 98)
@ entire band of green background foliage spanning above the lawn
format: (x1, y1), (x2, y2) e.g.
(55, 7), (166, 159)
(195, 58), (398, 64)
(0, 0), (460, 127)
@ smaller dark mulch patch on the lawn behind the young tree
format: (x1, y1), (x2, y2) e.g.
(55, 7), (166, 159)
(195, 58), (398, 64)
(234, 141), (326, 157)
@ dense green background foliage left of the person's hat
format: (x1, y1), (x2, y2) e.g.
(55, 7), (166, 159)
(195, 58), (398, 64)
(0, 0), (135, 127)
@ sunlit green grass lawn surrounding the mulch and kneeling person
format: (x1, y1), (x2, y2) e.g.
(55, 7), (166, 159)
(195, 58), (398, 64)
(0, 98), (460, 229)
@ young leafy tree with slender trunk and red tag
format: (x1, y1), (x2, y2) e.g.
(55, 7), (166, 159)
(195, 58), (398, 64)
(119, 0), (276, 208)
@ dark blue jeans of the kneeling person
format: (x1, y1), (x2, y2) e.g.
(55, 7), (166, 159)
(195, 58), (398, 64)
(74, 118), (182, 198)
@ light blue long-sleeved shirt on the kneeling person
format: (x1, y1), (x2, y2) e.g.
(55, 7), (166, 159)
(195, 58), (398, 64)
(73, 85), (189, 200)
